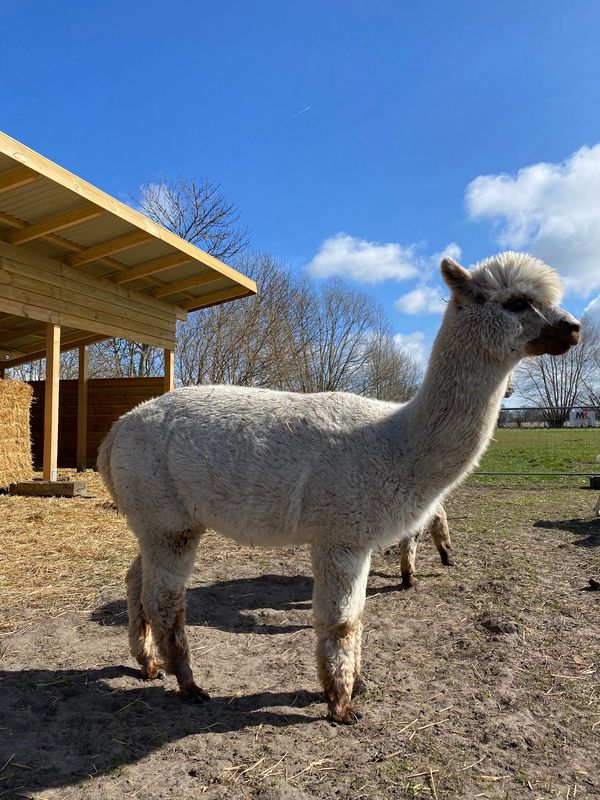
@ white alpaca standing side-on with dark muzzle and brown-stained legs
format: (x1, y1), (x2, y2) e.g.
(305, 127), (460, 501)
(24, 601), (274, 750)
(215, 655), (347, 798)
(98, 252), (579, 723)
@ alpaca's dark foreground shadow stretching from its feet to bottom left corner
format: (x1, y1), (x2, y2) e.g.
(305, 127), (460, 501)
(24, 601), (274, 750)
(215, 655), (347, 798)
(0, 667), (324, 797)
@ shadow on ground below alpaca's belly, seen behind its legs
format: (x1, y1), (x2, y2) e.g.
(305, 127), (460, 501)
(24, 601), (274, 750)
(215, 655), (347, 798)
(92, 572), (406, 634)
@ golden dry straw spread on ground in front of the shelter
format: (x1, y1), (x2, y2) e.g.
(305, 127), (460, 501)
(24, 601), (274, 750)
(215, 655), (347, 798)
(0, 470), (262, 636)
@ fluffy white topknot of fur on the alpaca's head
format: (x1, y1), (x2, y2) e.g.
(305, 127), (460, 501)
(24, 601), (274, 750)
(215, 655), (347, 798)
(471, 250), (563, 305)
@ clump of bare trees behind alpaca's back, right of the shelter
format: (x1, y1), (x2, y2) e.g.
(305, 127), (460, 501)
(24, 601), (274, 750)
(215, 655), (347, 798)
(176, 253), (419, 400)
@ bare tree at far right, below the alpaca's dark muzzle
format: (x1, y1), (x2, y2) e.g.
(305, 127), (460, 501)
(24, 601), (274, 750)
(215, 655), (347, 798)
(517, 319), (597, 427)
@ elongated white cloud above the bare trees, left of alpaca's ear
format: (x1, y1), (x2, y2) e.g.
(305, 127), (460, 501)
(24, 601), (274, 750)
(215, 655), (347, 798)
(308, 233), (419, 283)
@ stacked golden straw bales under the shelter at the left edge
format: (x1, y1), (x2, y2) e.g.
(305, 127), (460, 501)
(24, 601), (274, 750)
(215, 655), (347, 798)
(0, 380), (33, 488)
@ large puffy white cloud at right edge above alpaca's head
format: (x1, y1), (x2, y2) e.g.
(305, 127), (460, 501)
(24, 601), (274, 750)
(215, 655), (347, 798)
(466, 144), (600, 296)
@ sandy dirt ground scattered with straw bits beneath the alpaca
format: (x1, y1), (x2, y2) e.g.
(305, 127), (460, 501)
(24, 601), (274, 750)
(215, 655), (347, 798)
(0, 480), (600, 800)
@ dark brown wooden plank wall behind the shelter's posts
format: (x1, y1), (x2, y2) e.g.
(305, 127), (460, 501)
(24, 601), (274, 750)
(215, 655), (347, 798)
(30, 378), (164, 469)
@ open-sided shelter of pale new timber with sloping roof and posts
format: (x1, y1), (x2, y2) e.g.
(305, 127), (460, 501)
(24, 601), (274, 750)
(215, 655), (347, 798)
(0, 133), (256, 481)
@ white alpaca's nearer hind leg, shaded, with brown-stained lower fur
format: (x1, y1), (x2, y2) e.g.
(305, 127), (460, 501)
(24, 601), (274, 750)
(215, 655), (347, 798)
(142, 531), (209, 700)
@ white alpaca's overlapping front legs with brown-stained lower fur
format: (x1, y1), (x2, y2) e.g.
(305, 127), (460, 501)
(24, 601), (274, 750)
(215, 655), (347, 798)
(312, 545), (371, 724)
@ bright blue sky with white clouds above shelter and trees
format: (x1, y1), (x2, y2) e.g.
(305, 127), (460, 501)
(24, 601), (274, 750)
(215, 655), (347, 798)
(0, 0), (600, 362)
